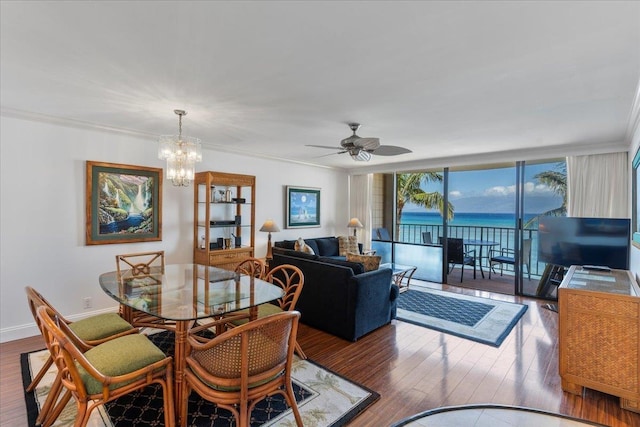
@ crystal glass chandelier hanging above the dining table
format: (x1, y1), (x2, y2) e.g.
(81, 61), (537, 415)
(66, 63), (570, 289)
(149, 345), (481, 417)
(158, 110), (202, 187)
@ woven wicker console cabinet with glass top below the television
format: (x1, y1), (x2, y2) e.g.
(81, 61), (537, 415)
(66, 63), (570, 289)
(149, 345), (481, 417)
(558, 266), (640, 412)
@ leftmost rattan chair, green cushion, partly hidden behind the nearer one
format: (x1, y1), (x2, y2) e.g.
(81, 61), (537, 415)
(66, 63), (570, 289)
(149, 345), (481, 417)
(25, 286), (139, 425)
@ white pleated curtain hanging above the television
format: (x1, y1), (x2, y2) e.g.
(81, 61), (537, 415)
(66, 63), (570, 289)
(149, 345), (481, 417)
(567, 153), (629, 218)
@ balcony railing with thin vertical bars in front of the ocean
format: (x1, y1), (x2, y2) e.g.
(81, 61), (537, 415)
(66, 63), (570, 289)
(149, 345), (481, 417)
(397, 224), (546, 278)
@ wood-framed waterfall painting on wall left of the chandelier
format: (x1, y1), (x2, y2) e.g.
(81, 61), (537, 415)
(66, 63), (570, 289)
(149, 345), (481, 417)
(86, 161), (162, 245)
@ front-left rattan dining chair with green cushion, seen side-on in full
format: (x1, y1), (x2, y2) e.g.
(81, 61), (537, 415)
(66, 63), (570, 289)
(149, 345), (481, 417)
(37, 306), (175, 427)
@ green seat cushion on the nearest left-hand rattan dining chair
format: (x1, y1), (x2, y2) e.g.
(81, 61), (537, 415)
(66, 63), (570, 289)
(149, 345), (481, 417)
(78, 334), (166, 394)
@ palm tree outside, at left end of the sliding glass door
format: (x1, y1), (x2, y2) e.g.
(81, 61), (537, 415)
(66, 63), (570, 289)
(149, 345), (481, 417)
(396, 172), (454, 236)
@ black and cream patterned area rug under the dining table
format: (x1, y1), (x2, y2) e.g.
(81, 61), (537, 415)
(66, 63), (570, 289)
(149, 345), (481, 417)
(20, 331), (380, 427)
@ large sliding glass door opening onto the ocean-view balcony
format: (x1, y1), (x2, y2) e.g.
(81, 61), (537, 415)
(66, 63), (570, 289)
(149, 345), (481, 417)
(372, 160), (566, 296)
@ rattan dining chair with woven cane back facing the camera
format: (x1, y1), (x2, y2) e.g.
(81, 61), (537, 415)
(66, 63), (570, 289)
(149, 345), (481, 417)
(178, 311), (302, 427)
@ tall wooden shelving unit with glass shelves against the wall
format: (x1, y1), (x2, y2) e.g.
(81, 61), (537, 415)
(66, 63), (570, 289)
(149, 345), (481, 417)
(193, 171), (256, 270)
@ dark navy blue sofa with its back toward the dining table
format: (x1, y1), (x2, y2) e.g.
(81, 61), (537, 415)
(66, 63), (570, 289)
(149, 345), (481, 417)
(270, 239), (399, 341)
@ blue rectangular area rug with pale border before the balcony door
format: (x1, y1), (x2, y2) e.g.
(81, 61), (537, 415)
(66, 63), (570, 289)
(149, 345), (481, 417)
(397, 287), (527, 347)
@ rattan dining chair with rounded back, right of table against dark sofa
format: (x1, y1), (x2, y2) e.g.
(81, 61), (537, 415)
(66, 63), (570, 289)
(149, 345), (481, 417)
(227, 264), (307, 359)
